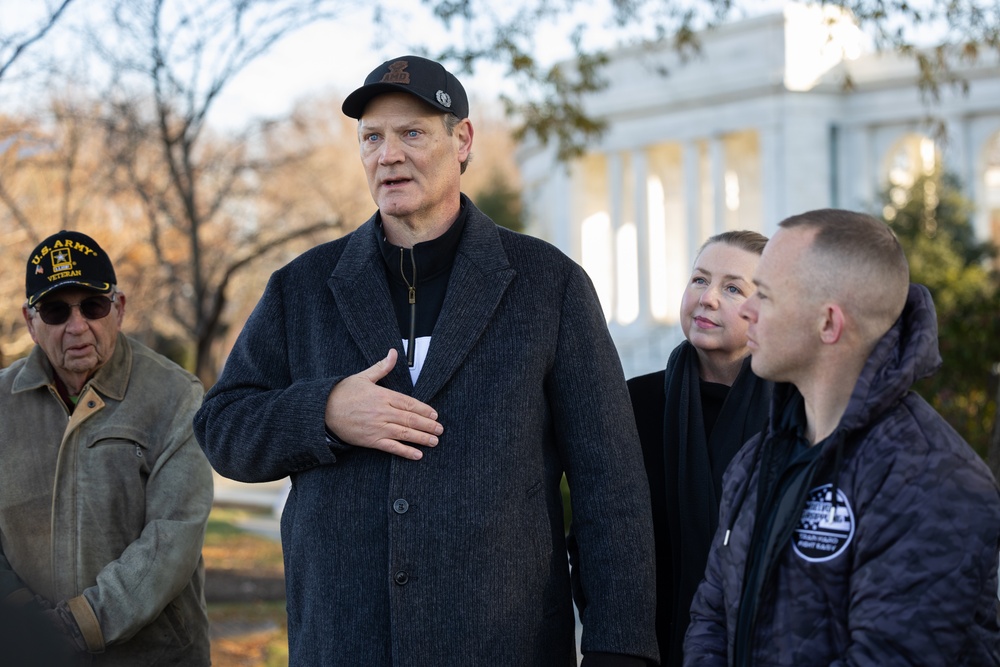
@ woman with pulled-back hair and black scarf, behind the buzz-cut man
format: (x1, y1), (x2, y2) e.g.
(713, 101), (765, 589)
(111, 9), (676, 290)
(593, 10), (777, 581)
(628, 231), (771, 667)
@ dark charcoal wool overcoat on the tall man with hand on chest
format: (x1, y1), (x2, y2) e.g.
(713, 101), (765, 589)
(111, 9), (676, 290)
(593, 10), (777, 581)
(195, 199), (657, 667)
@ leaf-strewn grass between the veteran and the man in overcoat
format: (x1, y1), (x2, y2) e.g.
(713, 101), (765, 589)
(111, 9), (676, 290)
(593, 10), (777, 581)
(202, 508), (288, 667)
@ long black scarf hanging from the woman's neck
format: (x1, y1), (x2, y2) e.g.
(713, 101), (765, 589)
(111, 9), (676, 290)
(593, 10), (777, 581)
(660, 341), (772, 665)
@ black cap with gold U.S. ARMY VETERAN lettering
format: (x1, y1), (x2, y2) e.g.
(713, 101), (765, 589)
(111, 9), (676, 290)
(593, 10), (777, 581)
(24, 229), (118, 306)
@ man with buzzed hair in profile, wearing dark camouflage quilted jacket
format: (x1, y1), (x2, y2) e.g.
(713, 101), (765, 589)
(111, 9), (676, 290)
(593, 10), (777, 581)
(684, 210), (1000, 667)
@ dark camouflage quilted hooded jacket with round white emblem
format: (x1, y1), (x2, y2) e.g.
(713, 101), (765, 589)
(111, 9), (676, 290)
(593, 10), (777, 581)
(684, 285), (1000, 667)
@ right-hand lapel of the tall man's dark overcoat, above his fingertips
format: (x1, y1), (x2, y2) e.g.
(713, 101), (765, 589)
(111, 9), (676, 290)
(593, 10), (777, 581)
(413, 203), (516, 402)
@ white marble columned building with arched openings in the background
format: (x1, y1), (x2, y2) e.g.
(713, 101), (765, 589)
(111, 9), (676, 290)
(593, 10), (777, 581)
(519, 3), (1000, 377)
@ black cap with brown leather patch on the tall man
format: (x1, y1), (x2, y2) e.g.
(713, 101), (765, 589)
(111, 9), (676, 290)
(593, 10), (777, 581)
(341, 56), (469, 120)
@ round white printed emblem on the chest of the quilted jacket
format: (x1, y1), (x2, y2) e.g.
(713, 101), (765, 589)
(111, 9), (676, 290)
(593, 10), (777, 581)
(792, 484), (854, 563)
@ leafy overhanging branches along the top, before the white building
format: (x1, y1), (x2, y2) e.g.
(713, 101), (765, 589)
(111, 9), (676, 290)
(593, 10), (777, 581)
(392, 0), (1000, 159)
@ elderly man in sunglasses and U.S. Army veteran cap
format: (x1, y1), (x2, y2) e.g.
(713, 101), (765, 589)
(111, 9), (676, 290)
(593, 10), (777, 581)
(0, 231), (212, 666)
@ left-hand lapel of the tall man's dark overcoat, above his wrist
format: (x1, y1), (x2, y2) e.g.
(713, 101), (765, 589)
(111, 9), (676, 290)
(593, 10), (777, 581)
(327, 216), (413, 394)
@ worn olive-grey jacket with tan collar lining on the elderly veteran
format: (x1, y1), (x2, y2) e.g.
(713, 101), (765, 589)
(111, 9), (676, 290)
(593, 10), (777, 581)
(0, 334), (212, 667)
